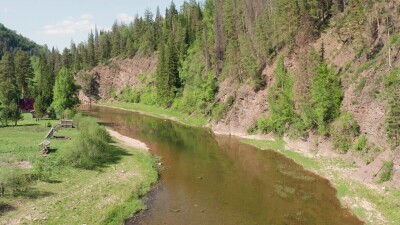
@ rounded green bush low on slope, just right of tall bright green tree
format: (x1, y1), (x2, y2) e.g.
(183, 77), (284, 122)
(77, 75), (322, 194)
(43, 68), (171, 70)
(331, 113), (362, 153)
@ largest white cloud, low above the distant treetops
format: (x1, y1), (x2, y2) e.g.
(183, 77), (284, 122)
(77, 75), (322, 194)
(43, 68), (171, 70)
(43, 14), (95, 35)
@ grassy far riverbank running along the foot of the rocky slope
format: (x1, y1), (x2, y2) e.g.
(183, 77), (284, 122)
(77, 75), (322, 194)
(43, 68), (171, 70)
(97, 102), (400, 224)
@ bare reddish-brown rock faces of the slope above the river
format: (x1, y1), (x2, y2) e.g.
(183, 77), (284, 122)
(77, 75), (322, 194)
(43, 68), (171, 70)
(78, 4), (400, 188)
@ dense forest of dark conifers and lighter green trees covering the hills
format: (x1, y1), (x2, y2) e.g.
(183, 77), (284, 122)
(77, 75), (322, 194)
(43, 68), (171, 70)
(0, 0), (400, 148)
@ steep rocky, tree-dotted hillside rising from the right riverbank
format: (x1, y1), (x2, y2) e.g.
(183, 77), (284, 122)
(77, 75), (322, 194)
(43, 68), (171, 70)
(74, 0), (400, 190)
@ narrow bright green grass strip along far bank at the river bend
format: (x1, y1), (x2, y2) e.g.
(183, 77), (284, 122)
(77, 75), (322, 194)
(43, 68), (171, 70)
(99, 102), (207, 127)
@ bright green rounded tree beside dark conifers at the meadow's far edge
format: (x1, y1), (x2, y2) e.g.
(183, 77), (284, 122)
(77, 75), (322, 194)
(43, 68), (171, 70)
(52, 67), (79, 115)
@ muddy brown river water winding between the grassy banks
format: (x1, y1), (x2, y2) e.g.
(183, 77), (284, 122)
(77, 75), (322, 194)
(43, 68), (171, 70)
(83, 106), (363, 225)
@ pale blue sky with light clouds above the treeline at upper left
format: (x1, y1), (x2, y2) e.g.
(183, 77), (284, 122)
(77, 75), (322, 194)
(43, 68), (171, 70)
(0, 0), (184, 51)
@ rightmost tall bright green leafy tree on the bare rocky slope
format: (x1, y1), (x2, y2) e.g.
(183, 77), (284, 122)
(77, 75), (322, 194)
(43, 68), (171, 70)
(311, 63), (343, 135)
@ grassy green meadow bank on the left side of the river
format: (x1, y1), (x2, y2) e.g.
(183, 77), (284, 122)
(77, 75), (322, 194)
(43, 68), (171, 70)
(0, 114), (158, 224)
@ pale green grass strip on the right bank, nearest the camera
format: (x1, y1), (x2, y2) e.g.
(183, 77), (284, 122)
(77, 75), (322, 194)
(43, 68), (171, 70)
(242, 138), (400, 225)
